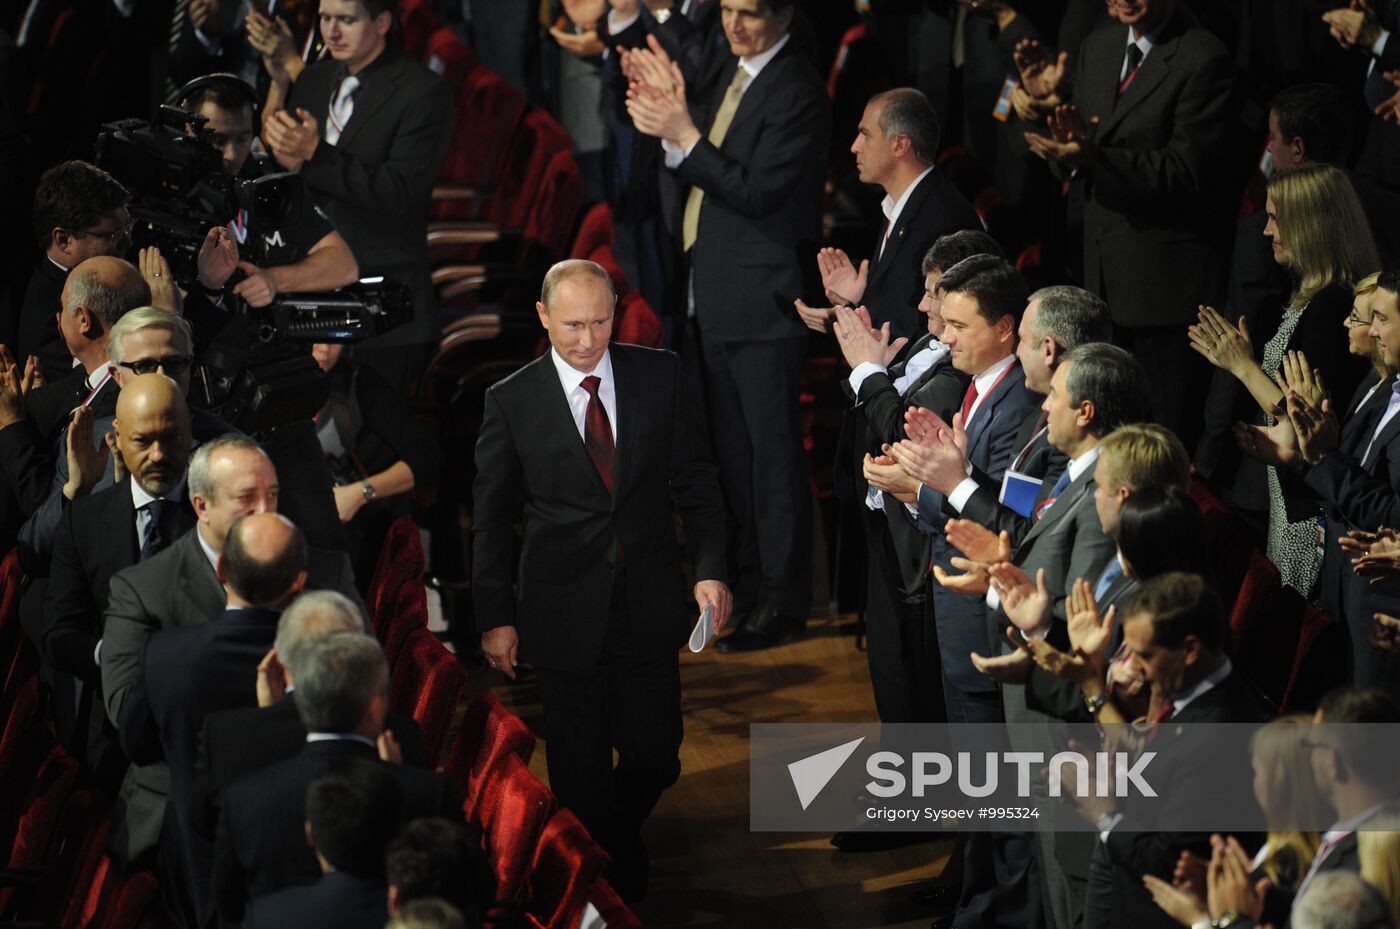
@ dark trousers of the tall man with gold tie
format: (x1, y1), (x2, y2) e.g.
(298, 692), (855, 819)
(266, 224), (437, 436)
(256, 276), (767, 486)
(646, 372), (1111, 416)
(686, 334), (812, 620)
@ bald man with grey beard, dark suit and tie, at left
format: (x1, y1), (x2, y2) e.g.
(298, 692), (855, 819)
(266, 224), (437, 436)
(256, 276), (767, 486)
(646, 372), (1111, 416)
(38, 374), (195, 786)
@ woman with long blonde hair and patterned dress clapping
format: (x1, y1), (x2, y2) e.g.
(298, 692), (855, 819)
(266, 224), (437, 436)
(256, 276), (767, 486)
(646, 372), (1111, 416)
(1189, 164), (1380, 595)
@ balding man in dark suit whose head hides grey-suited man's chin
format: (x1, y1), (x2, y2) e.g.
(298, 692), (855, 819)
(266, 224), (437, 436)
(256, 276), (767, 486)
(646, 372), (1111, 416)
(135, 514), (309, 925)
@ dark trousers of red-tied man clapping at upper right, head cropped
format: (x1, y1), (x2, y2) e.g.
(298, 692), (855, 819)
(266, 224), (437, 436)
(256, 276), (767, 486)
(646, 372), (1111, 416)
(1114, 323), (1211, 449)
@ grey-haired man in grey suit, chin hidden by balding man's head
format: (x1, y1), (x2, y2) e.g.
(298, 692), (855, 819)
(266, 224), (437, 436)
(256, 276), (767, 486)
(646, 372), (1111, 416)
(101, 435), (360, 865)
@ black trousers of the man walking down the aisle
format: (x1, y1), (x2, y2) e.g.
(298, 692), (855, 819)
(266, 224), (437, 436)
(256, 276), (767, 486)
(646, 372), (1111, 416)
(536, 572), (682, 893)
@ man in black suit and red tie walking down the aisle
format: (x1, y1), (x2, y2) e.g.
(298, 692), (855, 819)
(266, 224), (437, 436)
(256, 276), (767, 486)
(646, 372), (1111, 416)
(472, 260), (731, 897)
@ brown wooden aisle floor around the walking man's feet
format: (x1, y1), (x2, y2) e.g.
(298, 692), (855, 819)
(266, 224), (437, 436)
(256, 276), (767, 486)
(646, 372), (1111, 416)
(473, 617), (949, 929)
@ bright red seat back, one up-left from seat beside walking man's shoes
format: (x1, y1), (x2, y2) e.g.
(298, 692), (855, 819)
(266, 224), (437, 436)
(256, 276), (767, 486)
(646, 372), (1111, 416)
(476, 756), (554, 911)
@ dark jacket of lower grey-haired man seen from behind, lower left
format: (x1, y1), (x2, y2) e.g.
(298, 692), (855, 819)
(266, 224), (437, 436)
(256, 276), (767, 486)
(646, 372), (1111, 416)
(214, 740), (461, 926)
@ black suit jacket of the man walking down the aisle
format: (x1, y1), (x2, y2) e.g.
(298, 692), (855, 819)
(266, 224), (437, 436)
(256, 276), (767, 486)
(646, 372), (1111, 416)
(472, 344), (725, 670)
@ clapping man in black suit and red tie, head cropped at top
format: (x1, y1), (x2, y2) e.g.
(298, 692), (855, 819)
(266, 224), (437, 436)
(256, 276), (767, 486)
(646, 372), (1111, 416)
(1025, 0), (1236, 446)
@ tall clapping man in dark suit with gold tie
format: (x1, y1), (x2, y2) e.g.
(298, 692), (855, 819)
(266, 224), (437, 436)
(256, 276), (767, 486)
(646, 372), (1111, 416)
(627, 0), (830, 652)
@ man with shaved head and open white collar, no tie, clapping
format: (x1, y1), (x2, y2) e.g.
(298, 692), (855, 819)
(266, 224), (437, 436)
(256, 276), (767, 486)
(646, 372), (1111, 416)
(797, 87), (1001, 339)
